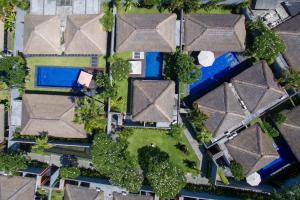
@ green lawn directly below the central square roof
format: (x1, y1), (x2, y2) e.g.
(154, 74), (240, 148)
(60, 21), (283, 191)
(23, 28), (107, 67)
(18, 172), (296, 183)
(128, 129), (200, 175)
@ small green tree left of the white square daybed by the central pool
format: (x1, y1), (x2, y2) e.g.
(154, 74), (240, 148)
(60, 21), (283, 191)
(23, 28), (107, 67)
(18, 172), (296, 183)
(110, 54), (131, 81)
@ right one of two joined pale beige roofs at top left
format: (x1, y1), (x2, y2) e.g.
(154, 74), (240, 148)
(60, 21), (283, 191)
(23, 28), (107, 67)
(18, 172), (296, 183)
(64, 14), (107, 54)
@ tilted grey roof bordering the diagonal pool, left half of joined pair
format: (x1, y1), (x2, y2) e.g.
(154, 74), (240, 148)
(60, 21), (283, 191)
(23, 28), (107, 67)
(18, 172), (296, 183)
(195, 83), (245, 138)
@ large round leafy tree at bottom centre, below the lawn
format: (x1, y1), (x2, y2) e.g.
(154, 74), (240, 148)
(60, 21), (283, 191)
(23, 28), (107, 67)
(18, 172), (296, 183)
(147, 160), (186, 199)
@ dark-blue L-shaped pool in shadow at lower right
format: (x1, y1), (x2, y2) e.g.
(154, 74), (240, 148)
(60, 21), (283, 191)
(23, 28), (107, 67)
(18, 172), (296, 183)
(258, 137), (296, 179)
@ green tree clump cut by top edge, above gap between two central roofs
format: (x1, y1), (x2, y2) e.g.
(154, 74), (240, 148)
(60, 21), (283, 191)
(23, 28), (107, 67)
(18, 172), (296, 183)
(161, 0), (200, 13)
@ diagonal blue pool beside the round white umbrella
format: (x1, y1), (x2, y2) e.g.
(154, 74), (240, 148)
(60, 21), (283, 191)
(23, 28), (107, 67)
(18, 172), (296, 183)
(189, 52), (240, 97)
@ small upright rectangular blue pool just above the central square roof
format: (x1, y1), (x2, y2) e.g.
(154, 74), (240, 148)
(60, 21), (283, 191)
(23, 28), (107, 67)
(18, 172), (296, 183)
(145, 52), (163, 79)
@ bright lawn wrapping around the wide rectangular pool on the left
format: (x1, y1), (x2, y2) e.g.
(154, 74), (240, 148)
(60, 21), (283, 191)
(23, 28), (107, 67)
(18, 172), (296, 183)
(25, 57), (91, 92)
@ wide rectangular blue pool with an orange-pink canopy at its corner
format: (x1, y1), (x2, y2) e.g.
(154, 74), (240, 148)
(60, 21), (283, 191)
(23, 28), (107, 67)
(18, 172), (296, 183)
(36, 66), (81, 88)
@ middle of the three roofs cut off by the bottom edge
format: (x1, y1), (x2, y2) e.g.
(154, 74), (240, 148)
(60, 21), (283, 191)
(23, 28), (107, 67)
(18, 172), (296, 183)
(64, 184), (104, 200)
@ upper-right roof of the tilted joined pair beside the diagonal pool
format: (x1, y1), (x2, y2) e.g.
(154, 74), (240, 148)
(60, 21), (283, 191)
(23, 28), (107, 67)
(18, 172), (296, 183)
(231, 61), (285, 113)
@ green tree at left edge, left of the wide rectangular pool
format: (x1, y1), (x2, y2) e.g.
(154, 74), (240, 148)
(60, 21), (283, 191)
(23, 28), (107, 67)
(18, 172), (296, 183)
(0, 56), (27, 87)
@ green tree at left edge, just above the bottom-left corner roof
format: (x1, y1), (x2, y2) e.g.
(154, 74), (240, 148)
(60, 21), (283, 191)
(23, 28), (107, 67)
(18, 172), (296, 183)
(0, 153), (27, 175)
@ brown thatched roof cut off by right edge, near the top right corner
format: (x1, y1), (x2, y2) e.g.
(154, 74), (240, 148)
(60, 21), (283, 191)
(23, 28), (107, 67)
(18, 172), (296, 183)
(274, 14), (300, 71)
